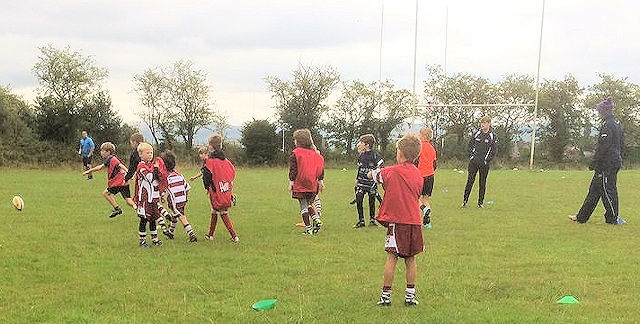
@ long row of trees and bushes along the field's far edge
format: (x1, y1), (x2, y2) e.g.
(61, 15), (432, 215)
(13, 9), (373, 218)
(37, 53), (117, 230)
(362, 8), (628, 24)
(0, 45), (640, 165)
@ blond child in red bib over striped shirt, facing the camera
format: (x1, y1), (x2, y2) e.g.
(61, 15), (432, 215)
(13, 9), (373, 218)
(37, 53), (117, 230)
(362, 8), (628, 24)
(135, 142), (167, 248)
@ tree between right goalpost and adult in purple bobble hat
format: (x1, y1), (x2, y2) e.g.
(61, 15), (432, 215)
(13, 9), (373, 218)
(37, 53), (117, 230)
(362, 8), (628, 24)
(537, 74), (586, 162)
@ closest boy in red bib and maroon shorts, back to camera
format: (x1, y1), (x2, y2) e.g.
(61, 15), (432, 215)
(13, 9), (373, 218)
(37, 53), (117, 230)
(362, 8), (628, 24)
(370, 134), (424, 306)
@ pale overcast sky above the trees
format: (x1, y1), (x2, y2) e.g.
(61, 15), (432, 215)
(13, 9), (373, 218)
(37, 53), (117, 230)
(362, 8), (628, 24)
(0, 0), (640, 125)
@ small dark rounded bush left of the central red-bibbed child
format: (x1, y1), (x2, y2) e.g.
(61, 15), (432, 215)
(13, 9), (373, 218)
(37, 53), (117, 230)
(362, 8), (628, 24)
(240, 119), (280, 165)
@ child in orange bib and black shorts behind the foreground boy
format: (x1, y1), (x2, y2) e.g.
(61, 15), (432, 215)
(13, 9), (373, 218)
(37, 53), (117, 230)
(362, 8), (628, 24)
(418, 127), (437, 228)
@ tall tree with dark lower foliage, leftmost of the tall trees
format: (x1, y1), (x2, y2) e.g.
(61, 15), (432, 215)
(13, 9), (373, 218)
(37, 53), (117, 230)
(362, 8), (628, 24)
(33, 45), (109, 143)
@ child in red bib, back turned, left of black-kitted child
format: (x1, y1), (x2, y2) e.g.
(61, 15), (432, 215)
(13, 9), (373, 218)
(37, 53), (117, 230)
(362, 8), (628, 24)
(289, 129), (324, 235)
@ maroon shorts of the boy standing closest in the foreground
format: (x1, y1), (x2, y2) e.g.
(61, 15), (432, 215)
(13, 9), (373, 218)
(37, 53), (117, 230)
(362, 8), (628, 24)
(384, 223), (424, 258)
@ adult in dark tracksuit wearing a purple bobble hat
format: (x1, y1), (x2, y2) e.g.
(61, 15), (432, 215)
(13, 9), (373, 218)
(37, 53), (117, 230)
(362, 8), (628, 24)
(569, 98), (626, 224)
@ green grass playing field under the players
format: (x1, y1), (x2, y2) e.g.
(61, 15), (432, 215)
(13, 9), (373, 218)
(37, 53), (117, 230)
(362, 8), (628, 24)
(0, 169), (640, 323)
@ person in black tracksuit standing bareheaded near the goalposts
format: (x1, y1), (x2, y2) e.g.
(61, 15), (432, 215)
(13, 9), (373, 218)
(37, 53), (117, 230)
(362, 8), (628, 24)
(462, 117), (498, 208)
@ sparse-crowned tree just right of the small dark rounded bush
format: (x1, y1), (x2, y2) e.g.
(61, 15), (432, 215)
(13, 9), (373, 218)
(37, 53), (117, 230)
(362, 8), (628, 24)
(265, 64), (340, 148)
